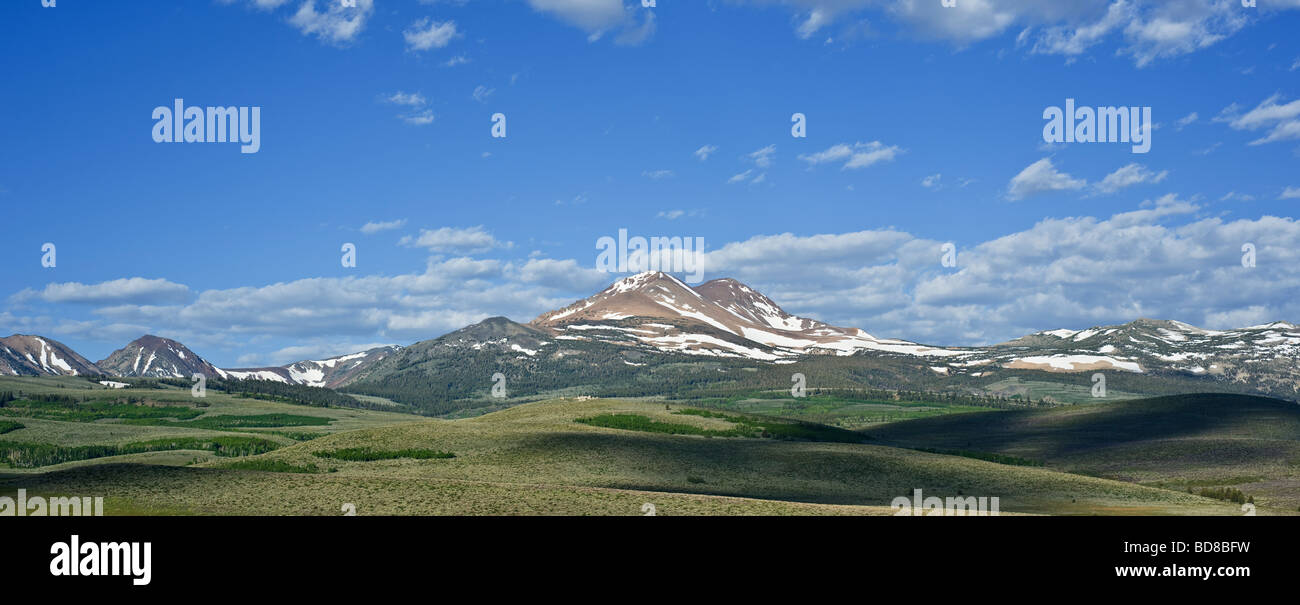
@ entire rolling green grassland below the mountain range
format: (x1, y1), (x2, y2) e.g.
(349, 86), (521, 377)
(0, 379), (1300, 515)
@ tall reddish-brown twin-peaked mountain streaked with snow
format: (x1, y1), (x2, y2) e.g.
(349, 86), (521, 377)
(532, 272), (963, 362)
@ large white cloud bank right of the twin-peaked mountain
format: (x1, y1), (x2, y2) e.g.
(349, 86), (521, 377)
(706, 195), (1300, 345)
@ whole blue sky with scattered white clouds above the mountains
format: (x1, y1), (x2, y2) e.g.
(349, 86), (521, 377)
(0, 0), (1300, 367)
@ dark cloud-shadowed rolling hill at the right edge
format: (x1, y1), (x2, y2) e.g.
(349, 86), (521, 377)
(865, 394), (1300, 510)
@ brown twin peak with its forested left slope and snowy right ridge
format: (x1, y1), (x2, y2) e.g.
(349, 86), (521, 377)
(342, 272), (1300, 414)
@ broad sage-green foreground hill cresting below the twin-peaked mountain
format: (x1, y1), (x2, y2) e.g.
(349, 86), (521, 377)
(0, 399), (1268, 515)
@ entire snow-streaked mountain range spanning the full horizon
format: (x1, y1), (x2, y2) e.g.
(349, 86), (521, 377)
(0, 272), (1300, 401)
